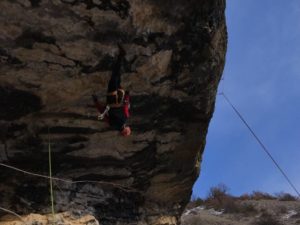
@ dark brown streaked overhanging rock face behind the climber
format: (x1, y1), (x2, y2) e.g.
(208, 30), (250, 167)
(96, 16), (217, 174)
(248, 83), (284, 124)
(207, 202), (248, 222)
(0, 0), (227, 225)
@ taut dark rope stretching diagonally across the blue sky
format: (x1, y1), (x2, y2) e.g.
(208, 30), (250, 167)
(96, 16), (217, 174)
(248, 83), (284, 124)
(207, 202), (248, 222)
(219, 92), (300, 197)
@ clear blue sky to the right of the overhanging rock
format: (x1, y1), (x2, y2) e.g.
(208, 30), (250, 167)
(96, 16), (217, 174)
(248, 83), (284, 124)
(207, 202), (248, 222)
(193, 0), (300, 197)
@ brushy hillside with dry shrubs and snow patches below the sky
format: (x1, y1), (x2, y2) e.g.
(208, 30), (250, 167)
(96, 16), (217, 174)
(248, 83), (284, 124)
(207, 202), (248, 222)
(182, 184), (300, 225)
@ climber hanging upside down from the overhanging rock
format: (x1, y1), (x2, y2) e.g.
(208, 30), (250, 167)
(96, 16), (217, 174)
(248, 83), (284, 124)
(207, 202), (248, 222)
(92, 44), (131, 136)
